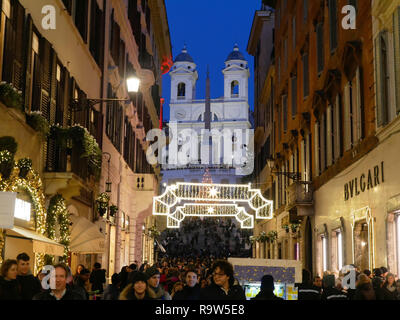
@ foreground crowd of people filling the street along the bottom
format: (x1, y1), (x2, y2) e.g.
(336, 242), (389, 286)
(0, 253), (400, 301)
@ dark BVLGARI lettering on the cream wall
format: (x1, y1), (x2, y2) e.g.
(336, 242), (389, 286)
(344, 161), (385, 201)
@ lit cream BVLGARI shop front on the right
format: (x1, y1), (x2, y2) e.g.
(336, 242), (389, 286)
(313, 129), (400, 275)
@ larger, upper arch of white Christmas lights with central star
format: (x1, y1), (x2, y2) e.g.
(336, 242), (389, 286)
(153, 182), (273, 228)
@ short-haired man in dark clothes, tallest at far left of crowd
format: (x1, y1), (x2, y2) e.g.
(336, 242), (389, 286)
(17, 253), (42, 300)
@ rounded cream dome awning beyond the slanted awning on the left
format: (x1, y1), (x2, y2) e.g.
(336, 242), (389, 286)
(70, 216), (104, 254)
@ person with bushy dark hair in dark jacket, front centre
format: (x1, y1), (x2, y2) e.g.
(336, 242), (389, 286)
(200, 260), (246, 300)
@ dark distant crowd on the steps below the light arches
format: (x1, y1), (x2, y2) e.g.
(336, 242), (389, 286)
(160, 217), (251, 258)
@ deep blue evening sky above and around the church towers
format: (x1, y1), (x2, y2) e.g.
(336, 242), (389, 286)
(163, 0), (261, 121)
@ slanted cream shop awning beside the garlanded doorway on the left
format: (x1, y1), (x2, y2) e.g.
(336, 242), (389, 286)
(7, 226), (64, 256)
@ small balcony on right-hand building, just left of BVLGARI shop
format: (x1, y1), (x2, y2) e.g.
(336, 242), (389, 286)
(287, 181), (314, 216)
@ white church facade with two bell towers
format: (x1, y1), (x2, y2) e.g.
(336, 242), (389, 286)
(163, 45), (253, 186)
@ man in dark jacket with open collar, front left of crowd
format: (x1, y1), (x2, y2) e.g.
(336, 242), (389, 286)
(33, 264), (82, 301)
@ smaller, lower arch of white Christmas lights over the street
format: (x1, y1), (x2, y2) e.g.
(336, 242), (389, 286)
(167, 203), (254, 229)
